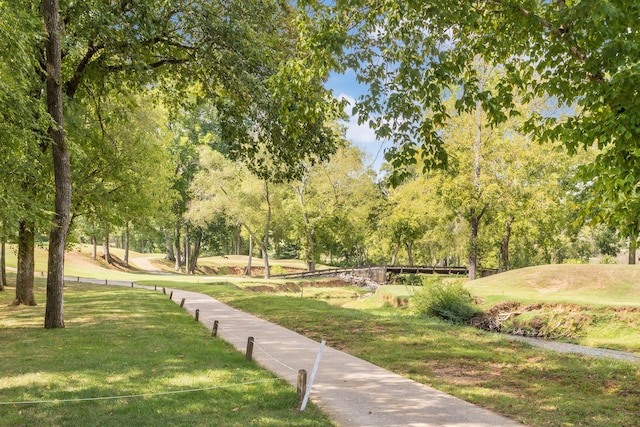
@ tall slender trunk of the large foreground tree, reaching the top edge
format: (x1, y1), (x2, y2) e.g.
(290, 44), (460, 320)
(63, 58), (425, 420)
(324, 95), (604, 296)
(43, 0), (71, 329)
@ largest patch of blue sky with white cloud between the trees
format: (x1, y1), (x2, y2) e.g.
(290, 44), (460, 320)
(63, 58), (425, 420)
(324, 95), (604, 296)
(327, 70), (390, 172)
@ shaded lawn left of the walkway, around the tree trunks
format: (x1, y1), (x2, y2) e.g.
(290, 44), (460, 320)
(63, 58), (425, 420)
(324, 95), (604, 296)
(0, 280), (332, 427)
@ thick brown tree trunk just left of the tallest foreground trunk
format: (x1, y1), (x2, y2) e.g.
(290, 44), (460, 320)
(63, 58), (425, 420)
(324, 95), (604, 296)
(13, 221), (37, 305)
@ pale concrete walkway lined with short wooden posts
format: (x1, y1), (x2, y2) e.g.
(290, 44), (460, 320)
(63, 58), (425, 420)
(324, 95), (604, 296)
(158, 286), (521, 427)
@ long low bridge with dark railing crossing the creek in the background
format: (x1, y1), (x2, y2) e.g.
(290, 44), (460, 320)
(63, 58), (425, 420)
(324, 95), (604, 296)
(271, 265), (498, 285)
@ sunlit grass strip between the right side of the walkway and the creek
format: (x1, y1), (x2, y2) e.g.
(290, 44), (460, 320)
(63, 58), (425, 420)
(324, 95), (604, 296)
(165, 284), (640, 426)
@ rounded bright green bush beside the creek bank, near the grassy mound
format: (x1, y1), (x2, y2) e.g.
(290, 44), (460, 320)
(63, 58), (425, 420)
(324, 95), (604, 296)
(413, 280), (478, 324)
